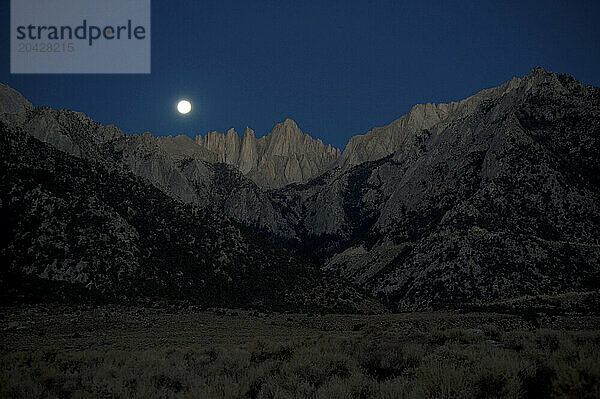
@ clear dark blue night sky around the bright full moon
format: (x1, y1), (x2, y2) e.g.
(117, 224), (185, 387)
(0, 0), (600, 148)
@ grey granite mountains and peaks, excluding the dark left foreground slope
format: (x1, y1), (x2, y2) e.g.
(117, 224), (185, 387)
(0, 68), (600, 309)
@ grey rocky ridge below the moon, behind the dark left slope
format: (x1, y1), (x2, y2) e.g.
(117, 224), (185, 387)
(0, 90), (297, 240)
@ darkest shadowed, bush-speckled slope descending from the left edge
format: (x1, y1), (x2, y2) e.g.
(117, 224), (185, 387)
(0, 120), (381, 311)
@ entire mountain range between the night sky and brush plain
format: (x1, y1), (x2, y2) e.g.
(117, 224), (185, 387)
(0, 67), (600, 311)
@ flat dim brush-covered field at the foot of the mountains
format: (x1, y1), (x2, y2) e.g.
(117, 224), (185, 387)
(0, 306), (600, 398)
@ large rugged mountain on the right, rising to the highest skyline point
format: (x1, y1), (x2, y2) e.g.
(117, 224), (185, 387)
(316, 70), (600, 309)
